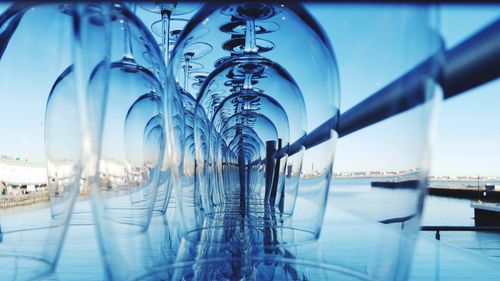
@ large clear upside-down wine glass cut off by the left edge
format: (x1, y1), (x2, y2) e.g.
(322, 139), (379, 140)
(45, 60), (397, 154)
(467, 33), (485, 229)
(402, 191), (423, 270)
(0, 3), (106, 280)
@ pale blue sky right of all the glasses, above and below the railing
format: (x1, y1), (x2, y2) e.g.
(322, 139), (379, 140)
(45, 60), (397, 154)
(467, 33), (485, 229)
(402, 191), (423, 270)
(433, 5), (500, 176)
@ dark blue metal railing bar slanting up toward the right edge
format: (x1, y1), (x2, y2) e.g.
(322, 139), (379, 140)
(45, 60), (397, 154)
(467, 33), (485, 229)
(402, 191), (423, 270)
(276, 17), (500, 156)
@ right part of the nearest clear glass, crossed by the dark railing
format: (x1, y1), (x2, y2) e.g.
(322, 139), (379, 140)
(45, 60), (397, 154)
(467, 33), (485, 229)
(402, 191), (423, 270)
(305, 4), (443, 280)
